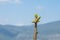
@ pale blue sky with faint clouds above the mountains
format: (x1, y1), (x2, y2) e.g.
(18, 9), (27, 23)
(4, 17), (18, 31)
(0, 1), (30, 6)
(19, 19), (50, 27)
(0, 0), (60, 26)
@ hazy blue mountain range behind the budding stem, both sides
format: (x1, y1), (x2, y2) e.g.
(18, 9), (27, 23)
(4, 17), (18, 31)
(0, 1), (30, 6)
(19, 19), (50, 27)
(0, 21), (60, 40)
